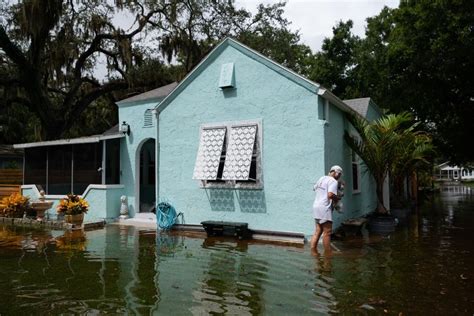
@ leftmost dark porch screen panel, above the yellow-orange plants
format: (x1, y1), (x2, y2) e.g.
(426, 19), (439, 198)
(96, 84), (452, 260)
(23, 147), (47, 192)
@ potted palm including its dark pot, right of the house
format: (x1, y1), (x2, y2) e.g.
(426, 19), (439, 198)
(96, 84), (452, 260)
(345, 112), (430, 233)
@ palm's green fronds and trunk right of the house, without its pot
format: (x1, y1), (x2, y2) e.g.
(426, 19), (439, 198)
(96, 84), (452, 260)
(345, 112), (431, 214)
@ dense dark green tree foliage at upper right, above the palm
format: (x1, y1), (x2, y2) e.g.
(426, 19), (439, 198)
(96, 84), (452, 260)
(311, 0), (474, 163)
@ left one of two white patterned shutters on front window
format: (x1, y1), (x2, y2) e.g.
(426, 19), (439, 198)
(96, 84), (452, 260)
(193, 127), (226, 180)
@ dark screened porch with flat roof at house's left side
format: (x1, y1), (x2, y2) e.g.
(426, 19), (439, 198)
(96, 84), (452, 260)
(14, 126), (124, 196)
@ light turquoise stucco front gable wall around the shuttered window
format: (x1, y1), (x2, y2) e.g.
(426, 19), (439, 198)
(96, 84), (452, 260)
(158, 47), (325, 234)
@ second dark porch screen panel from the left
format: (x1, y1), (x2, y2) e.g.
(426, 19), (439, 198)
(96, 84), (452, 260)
(47, 145), (72, 195)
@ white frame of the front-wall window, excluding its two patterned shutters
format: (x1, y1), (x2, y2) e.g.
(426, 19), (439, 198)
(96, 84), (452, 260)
(199, 120), (263, 190)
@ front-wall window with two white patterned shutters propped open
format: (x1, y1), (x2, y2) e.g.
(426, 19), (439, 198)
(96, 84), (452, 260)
(193, 121), (262, 189)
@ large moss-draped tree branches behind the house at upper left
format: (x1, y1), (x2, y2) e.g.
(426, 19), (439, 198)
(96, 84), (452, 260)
(0, 0), (312, 143)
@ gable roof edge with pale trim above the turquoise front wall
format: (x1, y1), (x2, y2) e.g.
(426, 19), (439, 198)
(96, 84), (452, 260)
(155, 37), (353, 113)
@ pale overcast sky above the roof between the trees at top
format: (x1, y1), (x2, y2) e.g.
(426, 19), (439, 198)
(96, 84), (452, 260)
(235, 0), (400, 51)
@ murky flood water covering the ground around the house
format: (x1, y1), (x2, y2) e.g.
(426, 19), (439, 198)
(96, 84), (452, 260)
(0, 186), (474, 315)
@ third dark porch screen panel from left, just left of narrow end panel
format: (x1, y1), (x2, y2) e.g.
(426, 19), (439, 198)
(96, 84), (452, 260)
(72, 143), (102, 195)
